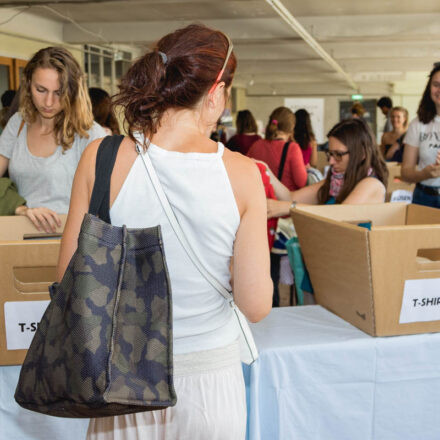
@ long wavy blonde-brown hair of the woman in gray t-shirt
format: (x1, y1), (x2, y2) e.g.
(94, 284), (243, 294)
(20, 47), (93, 151)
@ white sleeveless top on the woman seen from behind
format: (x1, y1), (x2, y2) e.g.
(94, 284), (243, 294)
(110, 139), (240, 354)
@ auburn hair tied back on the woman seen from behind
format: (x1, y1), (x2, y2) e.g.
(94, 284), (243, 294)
(114, 24), (237, 145)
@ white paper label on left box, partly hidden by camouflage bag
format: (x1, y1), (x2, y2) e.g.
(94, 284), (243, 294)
(4, 301), (49, 350)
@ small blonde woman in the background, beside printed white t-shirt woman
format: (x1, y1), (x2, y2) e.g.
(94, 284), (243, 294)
(380, 107), (408, 163)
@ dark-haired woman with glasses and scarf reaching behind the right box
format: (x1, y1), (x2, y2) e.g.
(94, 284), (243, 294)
(267, 119), (388, 217)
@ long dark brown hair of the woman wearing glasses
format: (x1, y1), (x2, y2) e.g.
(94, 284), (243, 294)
(318, 118), (388, 205)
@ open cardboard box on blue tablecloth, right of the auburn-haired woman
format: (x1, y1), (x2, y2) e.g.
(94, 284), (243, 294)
(291, 203), (440, 336)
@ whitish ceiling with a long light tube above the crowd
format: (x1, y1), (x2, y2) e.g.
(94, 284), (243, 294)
(0, 0), (440, 96)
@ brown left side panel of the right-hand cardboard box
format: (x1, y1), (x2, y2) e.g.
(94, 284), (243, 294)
(291, 205), (375, 333)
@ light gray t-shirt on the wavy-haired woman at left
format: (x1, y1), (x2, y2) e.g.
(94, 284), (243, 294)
(0, 113), (105, 214)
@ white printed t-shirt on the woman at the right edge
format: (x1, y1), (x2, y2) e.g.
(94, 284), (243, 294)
(403, 115), (440, 186)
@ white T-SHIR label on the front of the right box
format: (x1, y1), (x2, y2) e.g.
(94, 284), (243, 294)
(399, 278), (440, 324)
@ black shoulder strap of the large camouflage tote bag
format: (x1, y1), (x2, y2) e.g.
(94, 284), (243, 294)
(89, 135), (124, 223)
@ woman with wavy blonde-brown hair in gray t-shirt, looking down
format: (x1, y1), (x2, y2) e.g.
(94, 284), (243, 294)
(0, 47), (105, 232)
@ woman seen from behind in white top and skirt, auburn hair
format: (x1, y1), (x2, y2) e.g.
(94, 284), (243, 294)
(58, 25), (272, 440)
